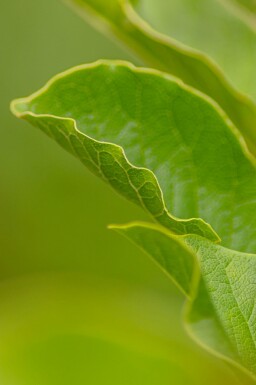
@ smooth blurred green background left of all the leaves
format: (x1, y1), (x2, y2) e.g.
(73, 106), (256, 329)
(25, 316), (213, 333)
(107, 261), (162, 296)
(0, 0), (243, 385)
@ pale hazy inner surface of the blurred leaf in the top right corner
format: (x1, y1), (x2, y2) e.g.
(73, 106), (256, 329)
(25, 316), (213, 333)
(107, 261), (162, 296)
(136, 0), (256, 97)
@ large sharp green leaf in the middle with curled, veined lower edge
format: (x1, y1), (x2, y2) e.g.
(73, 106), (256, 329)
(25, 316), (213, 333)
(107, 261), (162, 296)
(12, 61), (256, 251)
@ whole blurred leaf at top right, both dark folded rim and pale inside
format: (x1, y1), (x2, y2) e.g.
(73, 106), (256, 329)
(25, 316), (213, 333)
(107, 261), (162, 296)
(66, 0), (256, 155)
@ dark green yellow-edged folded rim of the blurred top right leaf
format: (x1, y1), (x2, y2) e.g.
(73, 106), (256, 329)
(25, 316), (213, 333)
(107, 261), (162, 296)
(66, 0), (256, 155)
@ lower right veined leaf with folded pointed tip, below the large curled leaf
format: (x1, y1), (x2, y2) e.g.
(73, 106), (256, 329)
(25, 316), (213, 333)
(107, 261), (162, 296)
(112, 219), (256, 381)
